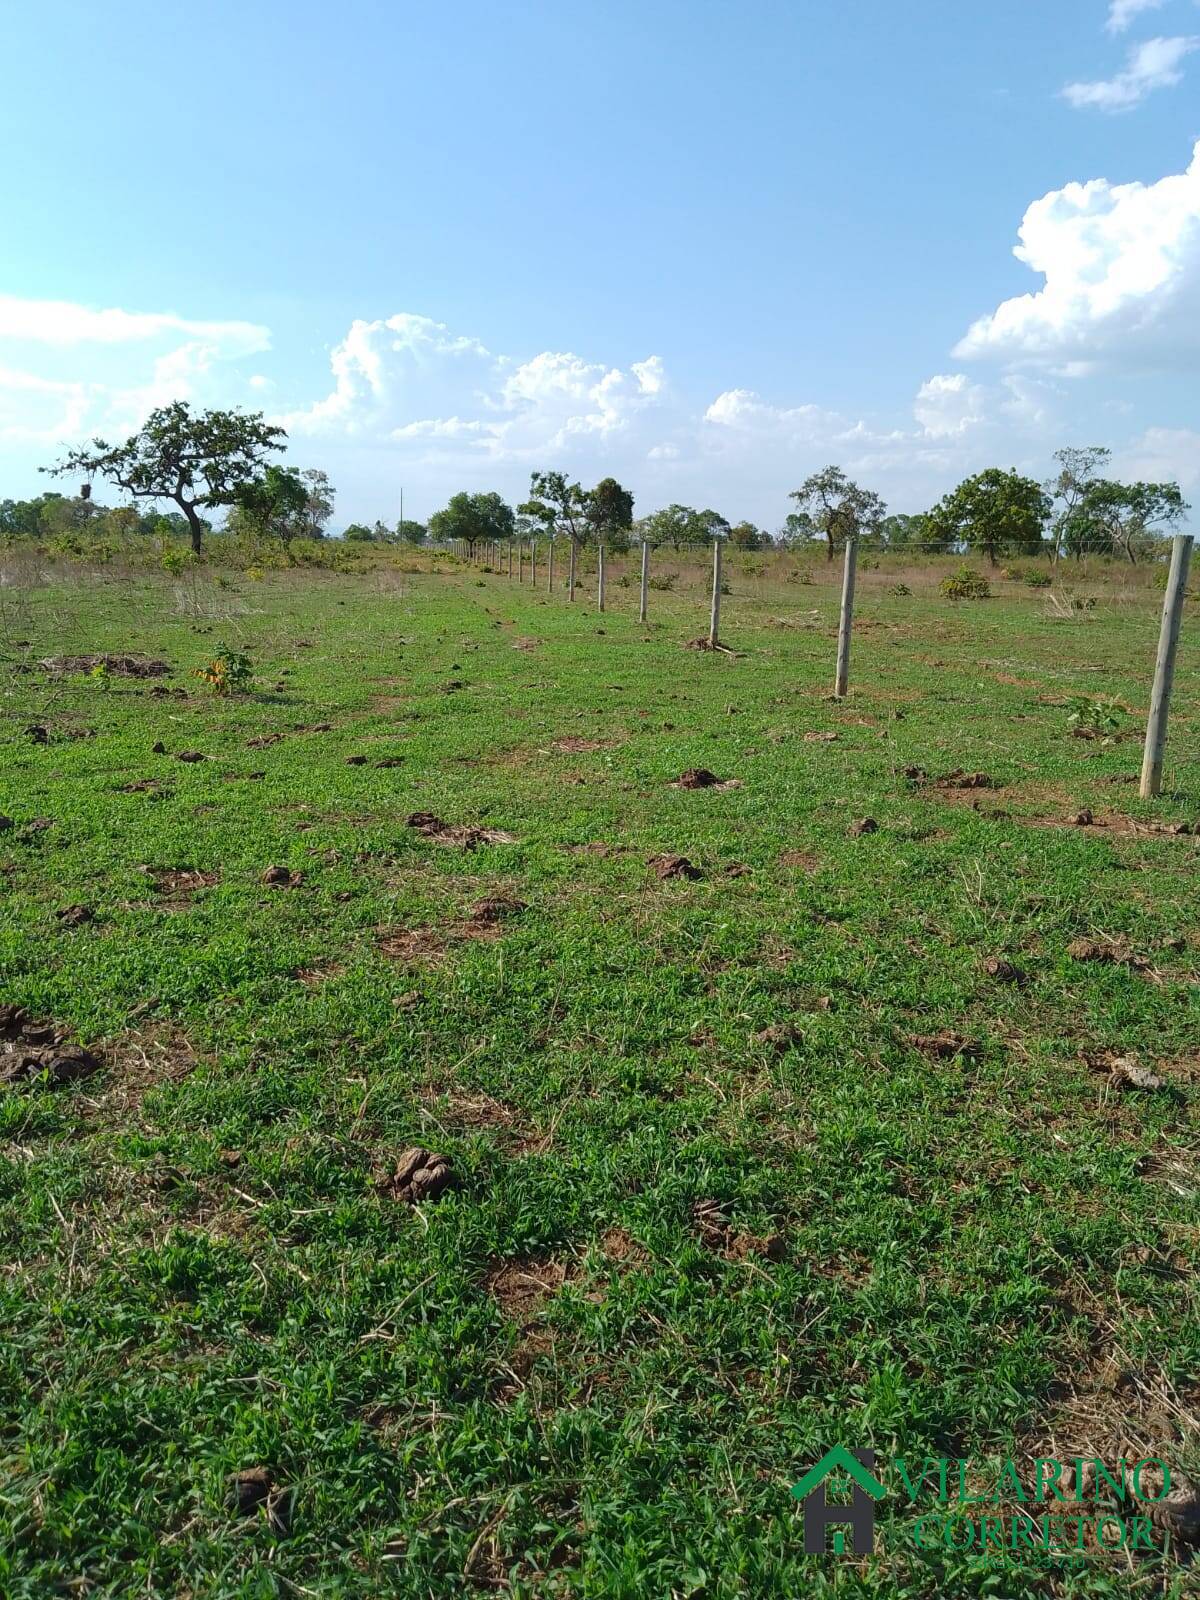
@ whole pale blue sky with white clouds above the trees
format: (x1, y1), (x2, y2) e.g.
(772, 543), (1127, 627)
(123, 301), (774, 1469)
(0, 0), (1200, 526)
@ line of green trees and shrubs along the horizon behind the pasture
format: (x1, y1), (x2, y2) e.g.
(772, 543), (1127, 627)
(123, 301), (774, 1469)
(0, 400), (1189, 565)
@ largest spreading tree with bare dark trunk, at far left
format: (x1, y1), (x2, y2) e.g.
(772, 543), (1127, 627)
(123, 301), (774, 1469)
(43, 400), (288, 555)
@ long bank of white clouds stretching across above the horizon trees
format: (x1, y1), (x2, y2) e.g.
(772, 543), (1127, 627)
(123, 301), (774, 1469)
(0, 142), (1200, 526)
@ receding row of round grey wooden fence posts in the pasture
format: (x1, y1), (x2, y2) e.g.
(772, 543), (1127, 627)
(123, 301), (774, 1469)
(450, 533), (1192, 800)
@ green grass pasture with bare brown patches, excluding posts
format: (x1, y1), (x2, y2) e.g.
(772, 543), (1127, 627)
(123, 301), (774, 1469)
(0, 547), (1200, 1600)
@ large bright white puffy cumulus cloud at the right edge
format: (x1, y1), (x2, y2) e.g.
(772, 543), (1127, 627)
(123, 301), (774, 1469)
(955, 142), (1200, 371)
